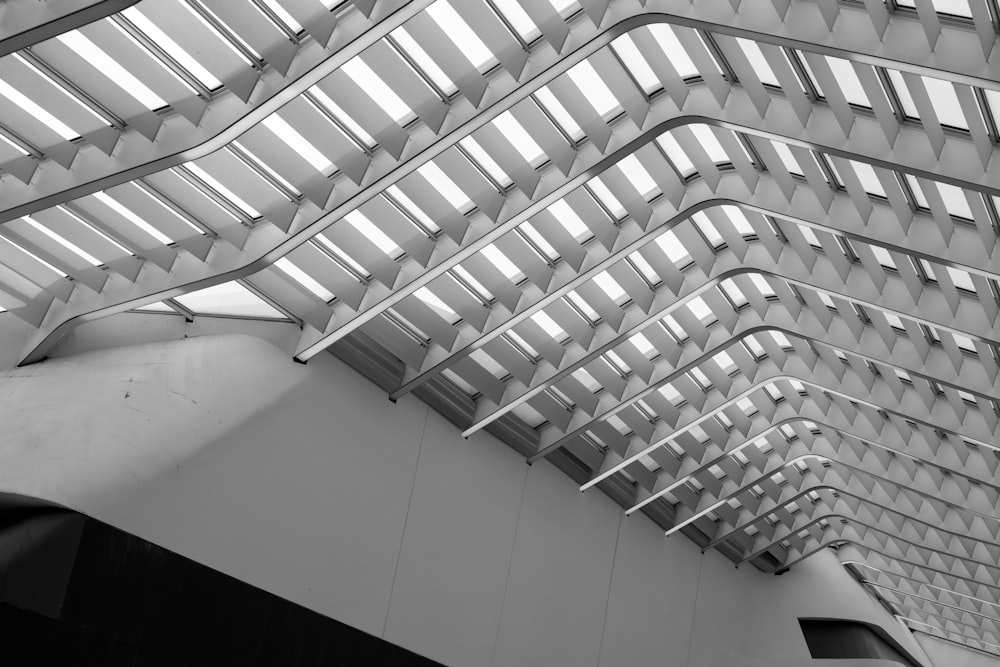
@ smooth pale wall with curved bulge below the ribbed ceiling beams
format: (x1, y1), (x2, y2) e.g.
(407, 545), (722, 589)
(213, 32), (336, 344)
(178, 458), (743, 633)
(0, 335), (929, 667)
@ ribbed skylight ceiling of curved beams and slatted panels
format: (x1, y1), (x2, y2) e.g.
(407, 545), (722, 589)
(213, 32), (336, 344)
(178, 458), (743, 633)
(0, 0), (1000, 654)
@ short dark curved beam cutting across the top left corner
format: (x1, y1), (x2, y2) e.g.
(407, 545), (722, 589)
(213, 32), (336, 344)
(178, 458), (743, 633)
(0, 0), (139, 58)
